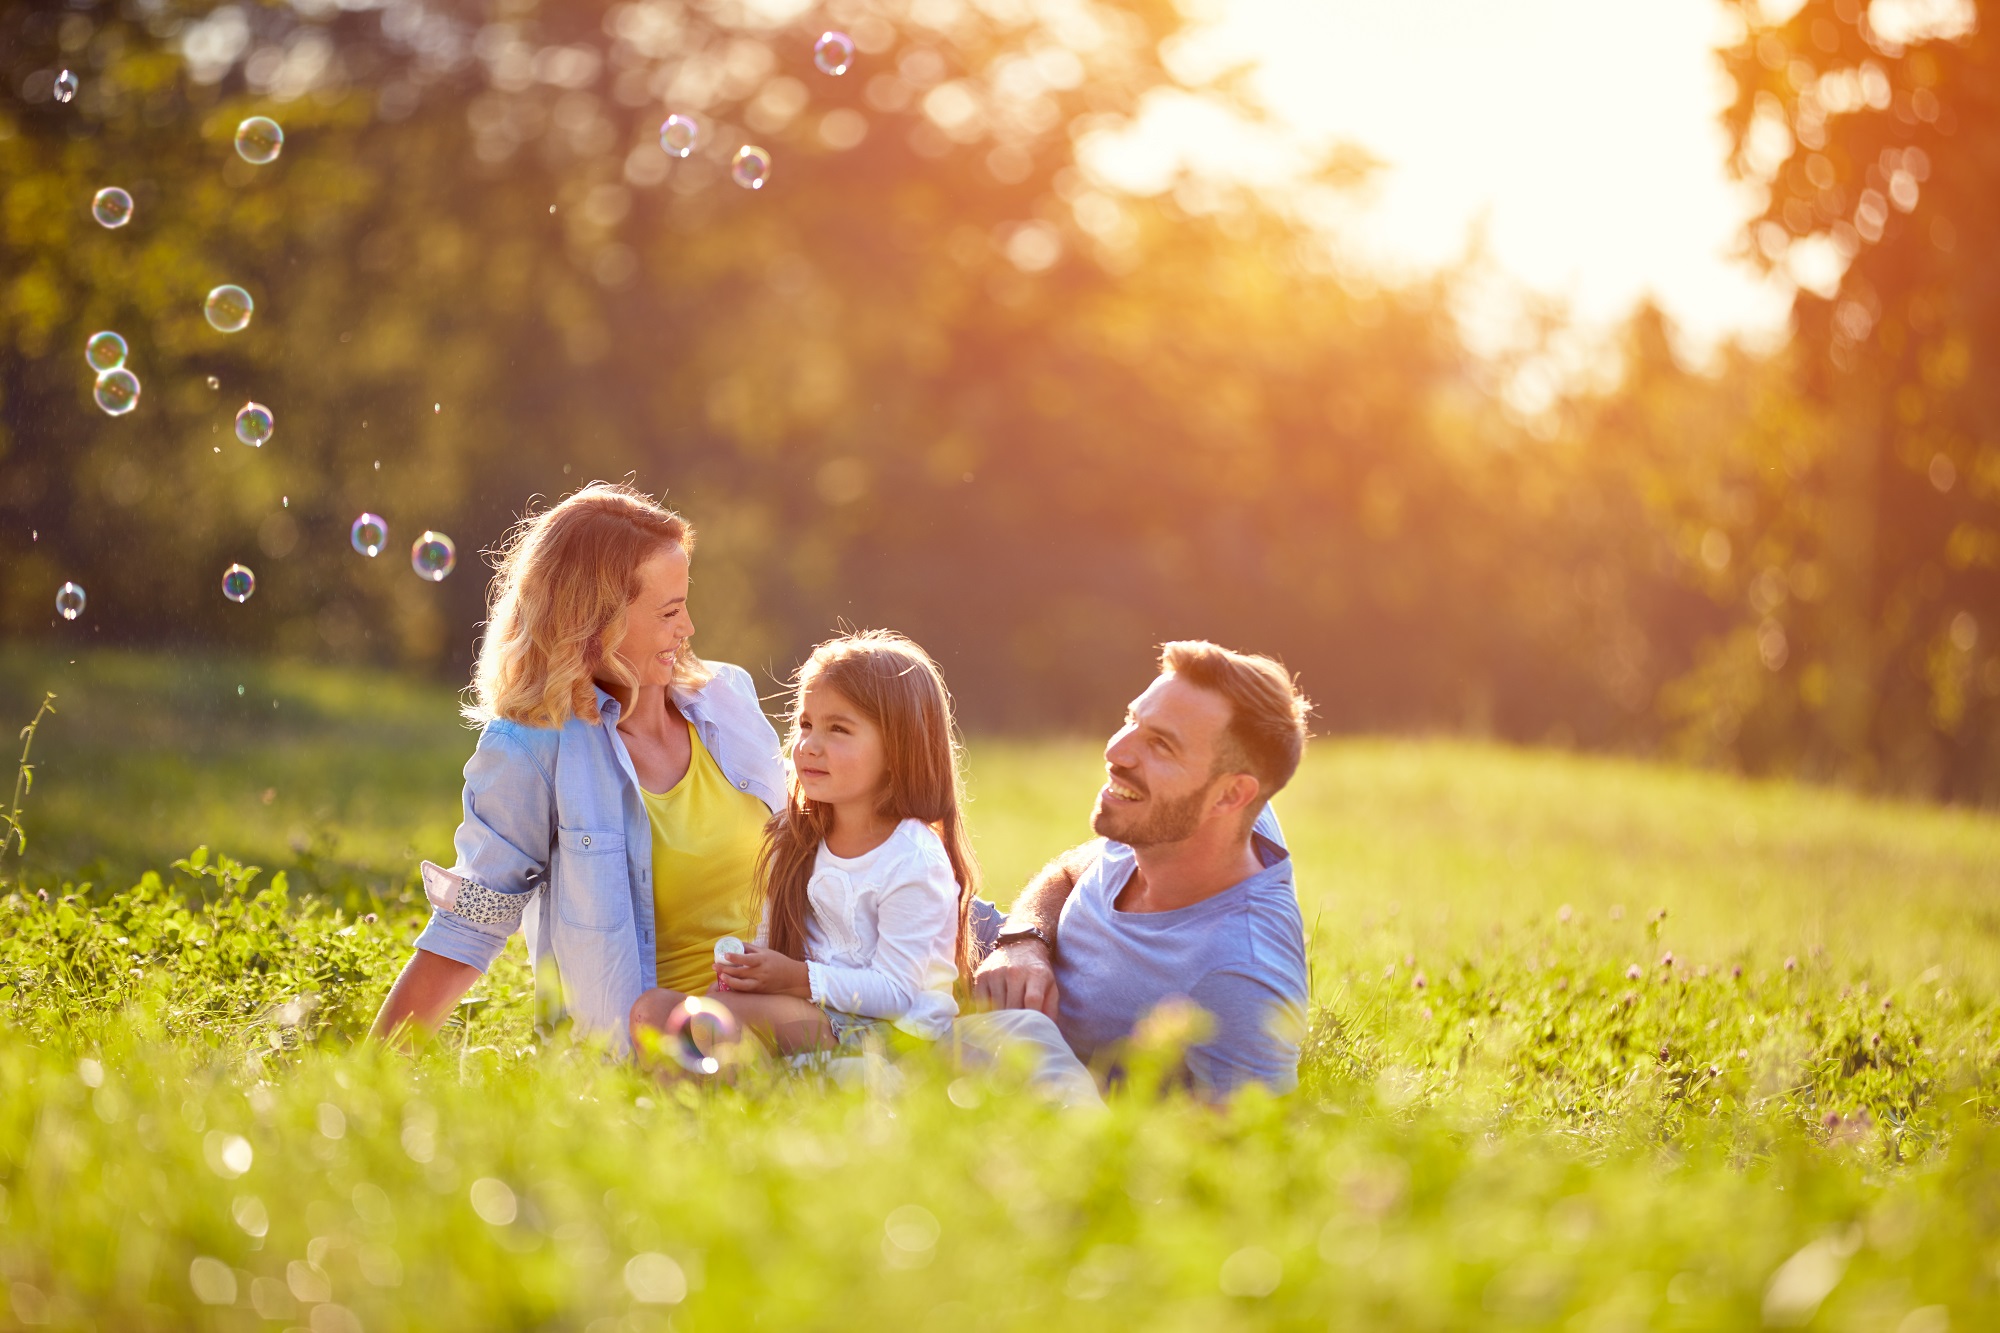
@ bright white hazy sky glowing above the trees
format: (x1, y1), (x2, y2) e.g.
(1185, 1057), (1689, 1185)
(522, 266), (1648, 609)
(1118, 0), (1790, 358)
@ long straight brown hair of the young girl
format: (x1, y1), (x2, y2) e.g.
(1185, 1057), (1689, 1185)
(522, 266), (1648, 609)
(758, 630), (980, 983)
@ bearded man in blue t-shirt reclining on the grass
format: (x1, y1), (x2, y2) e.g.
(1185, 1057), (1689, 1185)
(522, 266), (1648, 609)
(968, 640), (1312, 1101)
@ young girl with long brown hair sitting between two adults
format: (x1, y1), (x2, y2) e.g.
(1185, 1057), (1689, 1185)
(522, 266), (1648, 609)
(632, 630), (978, 1055)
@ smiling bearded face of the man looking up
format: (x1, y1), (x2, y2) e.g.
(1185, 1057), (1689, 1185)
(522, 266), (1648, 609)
(1090, 673), (1230, 847)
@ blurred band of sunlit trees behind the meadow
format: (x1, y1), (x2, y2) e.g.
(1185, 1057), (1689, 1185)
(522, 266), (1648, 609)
(0, 0), (2000, 801)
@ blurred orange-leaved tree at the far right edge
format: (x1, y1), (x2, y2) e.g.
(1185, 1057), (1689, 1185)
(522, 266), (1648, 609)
(1686, 0), (2000, 801)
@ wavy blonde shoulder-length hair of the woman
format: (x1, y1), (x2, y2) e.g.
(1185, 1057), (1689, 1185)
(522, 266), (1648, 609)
(464, 482), (712, 727)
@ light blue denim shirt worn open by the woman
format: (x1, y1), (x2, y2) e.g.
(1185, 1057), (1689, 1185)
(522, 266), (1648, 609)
(416, 662), (784, 1051)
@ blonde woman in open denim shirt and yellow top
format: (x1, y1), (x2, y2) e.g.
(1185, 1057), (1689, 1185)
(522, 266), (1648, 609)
(374, 482), (784, 1049)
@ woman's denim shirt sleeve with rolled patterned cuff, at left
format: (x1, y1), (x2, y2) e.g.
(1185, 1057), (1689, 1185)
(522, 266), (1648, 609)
(416, 725), (554, 973)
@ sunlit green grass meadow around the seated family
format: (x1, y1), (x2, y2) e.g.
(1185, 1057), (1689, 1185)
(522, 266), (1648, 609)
(0, 652), (2000, 1333)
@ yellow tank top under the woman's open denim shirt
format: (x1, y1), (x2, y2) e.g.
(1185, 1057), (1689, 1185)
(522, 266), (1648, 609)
(640, 727), (770, 995)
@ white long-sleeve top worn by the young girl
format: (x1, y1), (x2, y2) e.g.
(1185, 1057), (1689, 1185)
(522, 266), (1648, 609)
(776, 819), (958, 1041)
